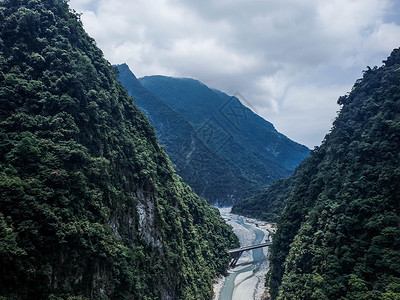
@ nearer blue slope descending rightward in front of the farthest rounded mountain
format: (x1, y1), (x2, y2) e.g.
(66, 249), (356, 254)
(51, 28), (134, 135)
(116, 64), (258, 205)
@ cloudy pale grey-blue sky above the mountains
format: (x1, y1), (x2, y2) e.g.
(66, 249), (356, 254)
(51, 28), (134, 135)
(69, 0), (400, 149)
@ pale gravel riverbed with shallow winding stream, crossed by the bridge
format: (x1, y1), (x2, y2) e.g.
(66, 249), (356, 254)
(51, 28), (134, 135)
(214, 208), (273, 300)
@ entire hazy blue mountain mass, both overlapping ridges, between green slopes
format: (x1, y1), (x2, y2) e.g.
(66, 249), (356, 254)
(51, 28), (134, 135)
(118, 65), (309, 204)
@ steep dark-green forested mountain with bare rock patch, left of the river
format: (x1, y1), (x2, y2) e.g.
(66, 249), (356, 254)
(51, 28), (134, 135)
(0, 0), (238, 299)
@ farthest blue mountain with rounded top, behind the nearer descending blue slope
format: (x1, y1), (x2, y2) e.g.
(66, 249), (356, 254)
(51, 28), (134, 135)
(134, 76), (309, 204)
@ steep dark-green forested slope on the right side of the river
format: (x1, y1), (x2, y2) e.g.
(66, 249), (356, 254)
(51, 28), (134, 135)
(269, 49), (400, 300)
